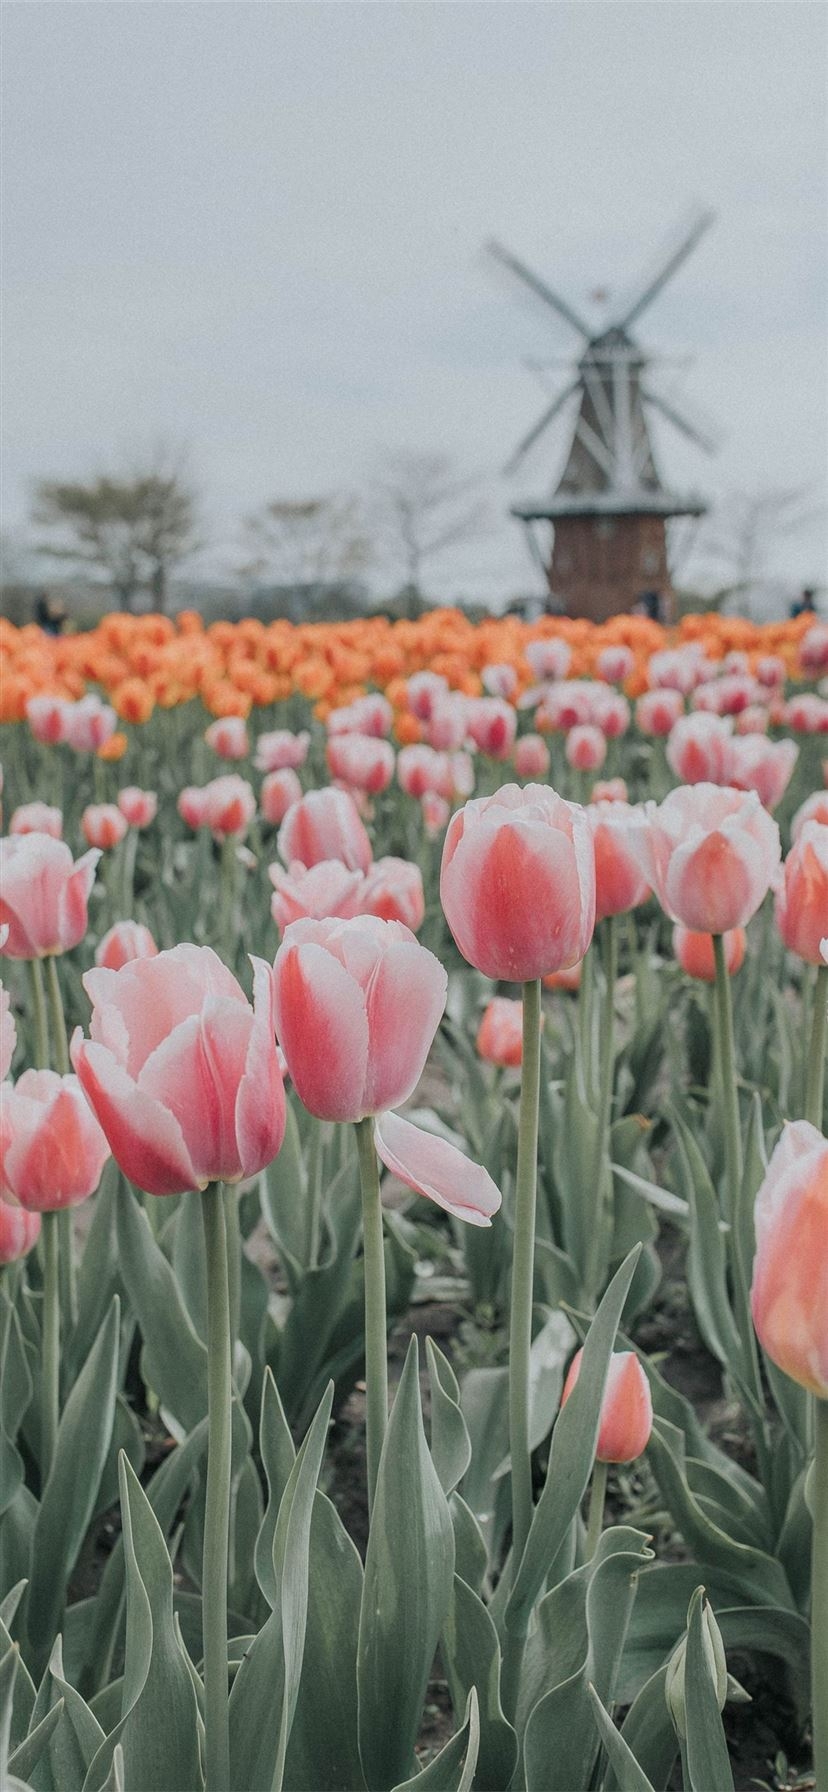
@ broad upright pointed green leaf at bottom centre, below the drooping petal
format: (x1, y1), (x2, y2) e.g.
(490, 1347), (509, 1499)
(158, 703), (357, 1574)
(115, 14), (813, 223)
(358, 1337), (453, 1792)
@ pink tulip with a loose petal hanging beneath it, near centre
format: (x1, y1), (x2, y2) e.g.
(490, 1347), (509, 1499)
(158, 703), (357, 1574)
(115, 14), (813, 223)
(274, 916), (448, 1120)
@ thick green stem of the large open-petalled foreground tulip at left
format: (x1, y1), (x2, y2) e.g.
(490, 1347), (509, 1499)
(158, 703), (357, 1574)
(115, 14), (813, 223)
(201, 1183), (233, 1792)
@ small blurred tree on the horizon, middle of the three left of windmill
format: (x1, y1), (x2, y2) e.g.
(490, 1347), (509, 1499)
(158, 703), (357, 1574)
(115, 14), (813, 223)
(242, 495), (373, 609)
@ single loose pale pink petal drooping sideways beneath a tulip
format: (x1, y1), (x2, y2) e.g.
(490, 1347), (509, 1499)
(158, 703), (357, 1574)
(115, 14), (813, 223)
(375, 1113), (500, 1226)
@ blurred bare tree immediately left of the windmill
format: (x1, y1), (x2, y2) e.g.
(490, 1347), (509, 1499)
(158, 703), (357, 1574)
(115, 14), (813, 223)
(375, 450), (489, 604)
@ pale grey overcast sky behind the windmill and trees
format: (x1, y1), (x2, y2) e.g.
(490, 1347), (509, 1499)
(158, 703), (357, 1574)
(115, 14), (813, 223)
(2, 0), (828, 599)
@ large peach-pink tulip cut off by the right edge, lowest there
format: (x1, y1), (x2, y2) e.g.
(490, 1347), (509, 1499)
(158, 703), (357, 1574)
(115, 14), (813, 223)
(751, 1120), (828, 1400)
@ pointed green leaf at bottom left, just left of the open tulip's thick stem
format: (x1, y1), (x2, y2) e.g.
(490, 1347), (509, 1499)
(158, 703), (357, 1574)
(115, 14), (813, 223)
(84, 1457), (201, 1792)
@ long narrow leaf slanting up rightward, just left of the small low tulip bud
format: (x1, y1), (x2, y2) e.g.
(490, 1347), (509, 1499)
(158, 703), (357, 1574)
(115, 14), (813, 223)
(505, 1247), (640, 1634)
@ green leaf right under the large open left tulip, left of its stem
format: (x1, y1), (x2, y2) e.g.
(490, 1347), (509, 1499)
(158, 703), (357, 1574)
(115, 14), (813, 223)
(118, 1185), (208, 1433)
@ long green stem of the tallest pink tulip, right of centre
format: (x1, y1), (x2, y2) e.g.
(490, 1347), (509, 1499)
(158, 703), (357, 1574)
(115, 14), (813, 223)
(509, 982), (541, 1579)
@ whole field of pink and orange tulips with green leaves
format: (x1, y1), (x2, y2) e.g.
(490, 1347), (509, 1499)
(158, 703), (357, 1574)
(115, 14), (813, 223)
(0, 611), (828, 1792)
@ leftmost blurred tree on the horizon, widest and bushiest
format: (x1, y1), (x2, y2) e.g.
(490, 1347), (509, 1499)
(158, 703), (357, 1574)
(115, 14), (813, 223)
(32, 452), (199, 609)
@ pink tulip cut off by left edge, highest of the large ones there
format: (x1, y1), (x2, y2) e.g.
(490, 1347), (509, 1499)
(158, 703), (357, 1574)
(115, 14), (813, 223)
(0, 833), (100, 959)
